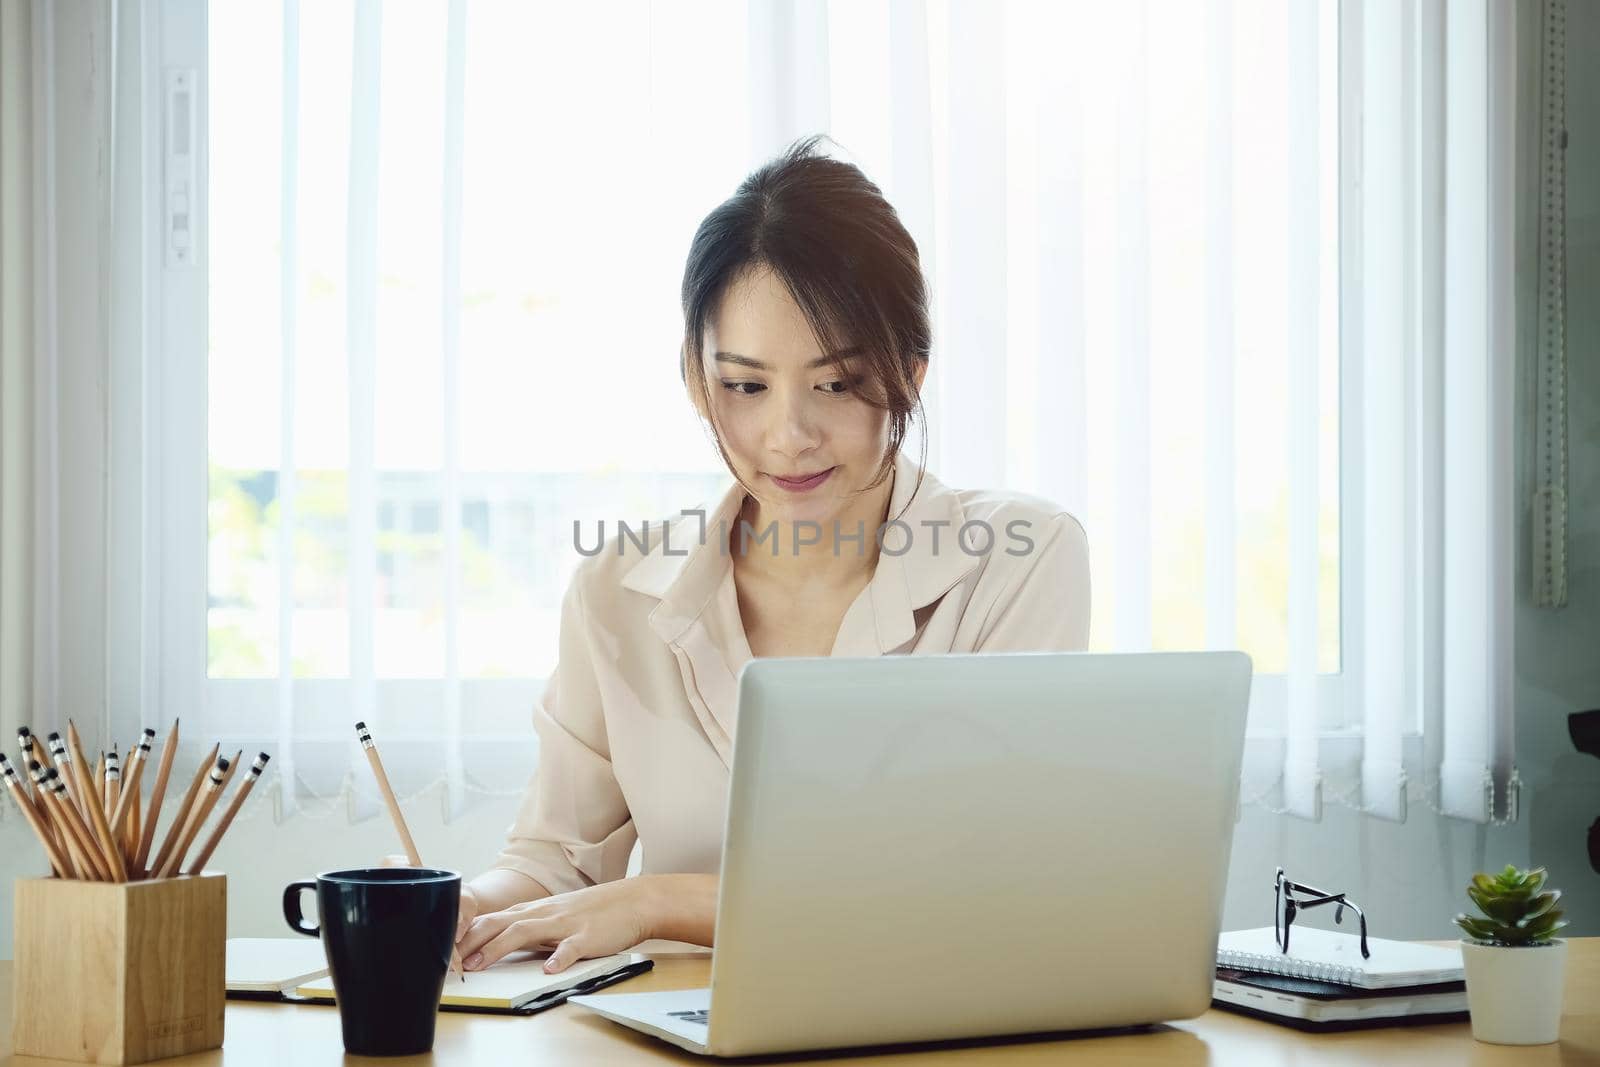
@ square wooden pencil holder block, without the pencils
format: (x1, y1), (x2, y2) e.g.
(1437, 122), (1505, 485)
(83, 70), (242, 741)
(11, 872), (227, 1064)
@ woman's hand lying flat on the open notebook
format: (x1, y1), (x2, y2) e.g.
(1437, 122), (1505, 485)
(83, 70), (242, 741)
(456, 877), (656, 974)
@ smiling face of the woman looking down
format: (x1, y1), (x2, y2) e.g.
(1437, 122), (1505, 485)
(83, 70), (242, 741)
(701, 267), (908, 531)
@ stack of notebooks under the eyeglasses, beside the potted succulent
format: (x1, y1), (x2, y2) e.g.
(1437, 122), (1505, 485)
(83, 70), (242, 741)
(1211, 926), (1467, 1030)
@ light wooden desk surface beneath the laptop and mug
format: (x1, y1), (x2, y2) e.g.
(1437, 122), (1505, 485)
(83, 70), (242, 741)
(0, 937), (1600, 1067)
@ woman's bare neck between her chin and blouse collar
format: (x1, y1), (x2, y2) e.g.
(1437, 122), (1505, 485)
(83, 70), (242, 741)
(730, 474), (894, 587)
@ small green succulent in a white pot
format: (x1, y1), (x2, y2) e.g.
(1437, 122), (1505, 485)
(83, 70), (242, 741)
(1456, 865), (1566, 1045)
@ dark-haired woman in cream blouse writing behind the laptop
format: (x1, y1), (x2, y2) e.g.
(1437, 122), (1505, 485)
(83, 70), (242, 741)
(458, 138), (1090, 973)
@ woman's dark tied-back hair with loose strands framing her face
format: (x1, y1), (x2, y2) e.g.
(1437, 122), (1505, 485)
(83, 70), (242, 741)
(678, 136), (933, 508)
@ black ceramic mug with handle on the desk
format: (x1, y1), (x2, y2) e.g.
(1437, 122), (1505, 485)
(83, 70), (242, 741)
(283, 867), (461, 1056)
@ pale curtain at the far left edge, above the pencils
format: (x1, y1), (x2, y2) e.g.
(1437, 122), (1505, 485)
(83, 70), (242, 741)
(0, 0), (124, 767)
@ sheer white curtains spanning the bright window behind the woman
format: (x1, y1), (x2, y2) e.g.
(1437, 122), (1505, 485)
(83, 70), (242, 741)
(28, 0), (1514, 821)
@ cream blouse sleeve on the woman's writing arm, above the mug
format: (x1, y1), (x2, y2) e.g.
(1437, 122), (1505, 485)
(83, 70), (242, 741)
(494, 573), (637, 894)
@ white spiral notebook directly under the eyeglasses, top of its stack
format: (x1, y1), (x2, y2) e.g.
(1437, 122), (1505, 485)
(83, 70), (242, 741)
(1216, 926), (1466, 989)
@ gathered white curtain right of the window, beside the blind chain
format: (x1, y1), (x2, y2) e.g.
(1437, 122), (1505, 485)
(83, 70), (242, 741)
(1346, 0), (1515, 821)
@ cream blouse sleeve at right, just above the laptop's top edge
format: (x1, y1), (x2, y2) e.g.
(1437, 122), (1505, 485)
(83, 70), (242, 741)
(974, 514), (1090, 653)
